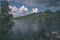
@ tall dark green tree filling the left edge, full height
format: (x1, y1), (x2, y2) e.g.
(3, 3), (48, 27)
(0, 0), (13, 40)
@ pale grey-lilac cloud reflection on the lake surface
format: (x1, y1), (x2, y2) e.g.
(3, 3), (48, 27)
(13, 19), (38, 32)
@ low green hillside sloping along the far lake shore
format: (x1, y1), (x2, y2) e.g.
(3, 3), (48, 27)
(15, 13), (60, 20)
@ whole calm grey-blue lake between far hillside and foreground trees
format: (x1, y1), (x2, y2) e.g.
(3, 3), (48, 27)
(12, 19), (60, 40)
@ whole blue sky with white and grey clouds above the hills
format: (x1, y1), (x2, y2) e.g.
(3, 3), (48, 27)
(0, 0), (60, 16)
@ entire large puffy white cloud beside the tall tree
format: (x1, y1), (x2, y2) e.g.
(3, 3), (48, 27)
(9, 5), (29, 17)
